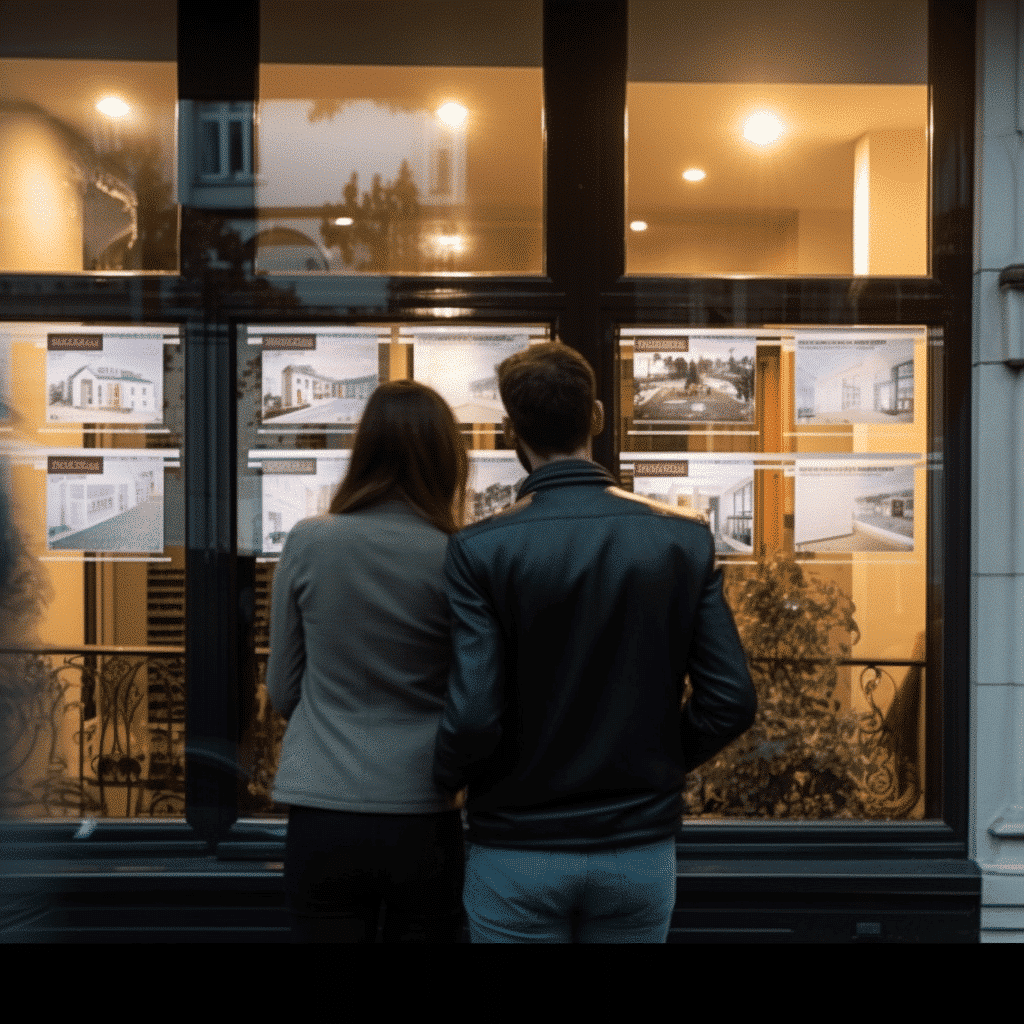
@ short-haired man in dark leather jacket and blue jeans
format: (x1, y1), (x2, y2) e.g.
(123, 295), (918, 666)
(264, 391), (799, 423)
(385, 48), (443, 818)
(434, 343), (757, 942)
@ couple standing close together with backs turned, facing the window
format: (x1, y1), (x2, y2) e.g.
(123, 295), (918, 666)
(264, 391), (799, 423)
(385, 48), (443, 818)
(267, 343), (757, 942)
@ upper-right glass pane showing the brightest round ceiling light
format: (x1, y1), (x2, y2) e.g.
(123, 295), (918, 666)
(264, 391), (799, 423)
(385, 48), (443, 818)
(626, 0), (929, 276)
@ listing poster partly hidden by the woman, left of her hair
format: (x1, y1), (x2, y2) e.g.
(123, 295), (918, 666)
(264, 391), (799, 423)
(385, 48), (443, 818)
(249, 452), (348, 555)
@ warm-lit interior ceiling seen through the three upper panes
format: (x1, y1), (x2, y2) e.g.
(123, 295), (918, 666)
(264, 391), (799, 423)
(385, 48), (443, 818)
(0, 59), (928, 218)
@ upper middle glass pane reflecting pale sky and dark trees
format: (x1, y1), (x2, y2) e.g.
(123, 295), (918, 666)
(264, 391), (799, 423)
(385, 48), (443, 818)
(256, 0), (544, 274)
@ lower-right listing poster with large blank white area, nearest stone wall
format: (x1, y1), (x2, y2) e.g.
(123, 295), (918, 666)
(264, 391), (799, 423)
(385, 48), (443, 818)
(794, 456), (919, 552)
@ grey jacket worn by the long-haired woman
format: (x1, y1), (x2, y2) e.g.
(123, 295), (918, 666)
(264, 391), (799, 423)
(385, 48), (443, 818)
(267, 501), (451, 814)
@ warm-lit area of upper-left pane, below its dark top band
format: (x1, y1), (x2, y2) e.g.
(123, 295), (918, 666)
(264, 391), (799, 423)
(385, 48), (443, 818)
(0, 57), (178, 272)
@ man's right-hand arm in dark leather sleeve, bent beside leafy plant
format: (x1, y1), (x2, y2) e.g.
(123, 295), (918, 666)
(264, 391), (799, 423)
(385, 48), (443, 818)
(682, 540), (758, 771)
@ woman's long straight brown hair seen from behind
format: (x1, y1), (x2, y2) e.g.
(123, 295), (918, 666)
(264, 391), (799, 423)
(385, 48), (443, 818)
(328, 381), (469, 534)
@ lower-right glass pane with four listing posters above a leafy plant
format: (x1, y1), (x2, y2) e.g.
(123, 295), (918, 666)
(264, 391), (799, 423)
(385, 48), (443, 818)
(617, 325), (941, 819)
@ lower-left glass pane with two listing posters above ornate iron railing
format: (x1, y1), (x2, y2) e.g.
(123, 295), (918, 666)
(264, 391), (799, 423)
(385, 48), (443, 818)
(0, 323), (185, 817)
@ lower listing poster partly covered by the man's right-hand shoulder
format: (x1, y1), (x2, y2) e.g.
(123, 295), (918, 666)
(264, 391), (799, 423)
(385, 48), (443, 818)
(622, 454), (757, 554)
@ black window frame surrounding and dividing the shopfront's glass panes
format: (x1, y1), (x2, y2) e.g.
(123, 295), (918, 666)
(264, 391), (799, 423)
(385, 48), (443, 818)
(0, 0), (976, 860)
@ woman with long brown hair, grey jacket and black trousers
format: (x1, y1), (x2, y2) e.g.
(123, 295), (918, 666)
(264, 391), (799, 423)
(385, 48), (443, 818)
(267, 381), (468, 942)
